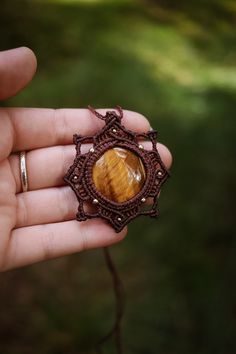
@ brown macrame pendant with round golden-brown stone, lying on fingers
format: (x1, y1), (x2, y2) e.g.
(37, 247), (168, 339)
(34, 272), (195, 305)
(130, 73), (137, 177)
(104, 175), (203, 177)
(64, 106), (169, 232)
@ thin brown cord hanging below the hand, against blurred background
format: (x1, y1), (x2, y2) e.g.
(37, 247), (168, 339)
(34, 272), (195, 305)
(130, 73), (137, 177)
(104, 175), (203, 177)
(96, 247), (124, 354)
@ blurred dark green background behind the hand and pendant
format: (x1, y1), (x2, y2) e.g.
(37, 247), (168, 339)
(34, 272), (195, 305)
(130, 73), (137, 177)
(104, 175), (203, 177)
(0, 0), (236, 354)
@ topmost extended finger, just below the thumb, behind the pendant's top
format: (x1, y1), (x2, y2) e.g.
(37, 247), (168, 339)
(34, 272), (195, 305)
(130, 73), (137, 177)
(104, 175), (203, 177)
(0, 108), (150, 151)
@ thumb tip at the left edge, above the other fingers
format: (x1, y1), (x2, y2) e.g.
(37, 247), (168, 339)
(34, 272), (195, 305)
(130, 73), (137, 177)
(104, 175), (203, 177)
(0, 47), (37, 100)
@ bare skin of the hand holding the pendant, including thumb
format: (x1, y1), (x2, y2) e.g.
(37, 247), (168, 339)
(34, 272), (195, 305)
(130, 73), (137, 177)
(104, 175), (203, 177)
(0, 47), (172, 271)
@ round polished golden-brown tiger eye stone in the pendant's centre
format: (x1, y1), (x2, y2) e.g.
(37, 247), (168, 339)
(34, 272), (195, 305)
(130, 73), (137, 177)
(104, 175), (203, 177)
(93, 147), (146, 203)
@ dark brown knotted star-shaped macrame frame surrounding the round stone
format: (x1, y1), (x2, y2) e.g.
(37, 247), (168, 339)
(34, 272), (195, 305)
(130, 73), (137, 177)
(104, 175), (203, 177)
(64, 106), (169, 232)
